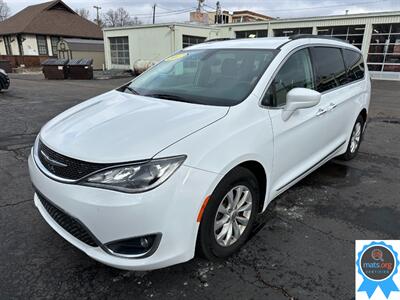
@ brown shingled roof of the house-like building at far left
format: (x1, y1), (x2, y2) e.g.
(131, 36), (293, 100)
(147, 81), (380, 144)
(0, 0), (103, 39)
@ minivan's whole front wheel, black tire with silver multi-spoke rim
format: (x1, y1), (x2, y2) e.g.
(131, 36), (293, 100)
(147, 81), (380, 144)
(197, 167), (260, 260)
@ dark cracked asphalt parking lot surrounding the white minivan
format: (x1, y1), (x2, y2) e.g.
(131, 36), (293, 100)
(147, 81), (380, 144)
(0, 75), (400, 299)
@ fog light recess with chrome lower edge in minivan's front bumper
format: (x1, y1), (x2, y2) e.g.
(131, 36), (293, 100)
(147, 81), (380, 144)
(104, 234), (161, 257)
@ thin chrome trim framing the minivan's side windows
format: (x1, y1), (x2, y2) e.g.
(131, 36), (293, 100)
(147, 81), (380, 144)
(258, 43), (367, 110)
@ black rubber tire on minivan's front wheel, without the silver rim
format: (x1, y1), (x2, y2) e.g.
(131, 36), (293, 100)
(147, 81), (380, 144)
(197, 167), (260, 260)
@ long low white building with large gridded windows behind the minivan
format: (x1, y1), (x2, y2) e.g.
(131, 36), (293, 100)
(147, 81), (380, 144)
(104, 11), (400, 79)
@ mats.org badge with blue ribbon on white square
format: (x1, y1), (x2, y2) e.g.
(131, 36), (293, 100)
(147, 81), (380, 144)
(355, 240), (400, 300)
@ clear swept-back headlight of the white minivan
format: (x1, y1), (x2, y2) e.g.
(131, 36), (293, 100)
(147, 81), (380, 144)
(82, 155), (186, 193)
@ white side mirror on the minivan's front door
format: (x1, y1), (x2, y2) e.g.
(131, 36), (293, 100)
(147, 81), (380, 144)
(282, 88), (321, 121)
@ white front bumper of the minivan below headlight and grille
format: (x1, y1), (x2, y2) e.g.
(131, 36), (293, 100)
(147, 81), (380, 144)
(29, 155), (220, 270)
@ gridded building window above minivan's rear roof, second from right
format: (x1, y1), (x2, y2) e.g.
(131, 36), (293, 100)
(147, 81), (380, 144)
(317, 25), (365, 49)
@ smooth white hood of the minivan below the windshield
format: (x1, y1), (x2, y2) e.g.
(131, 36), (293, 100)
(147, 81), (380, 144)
(40, 91), (229, 163)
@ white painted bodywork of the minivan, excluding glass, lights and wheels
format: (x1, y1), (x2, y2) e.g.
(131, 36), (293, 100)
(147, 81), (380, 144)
(29, 38), (371, 270)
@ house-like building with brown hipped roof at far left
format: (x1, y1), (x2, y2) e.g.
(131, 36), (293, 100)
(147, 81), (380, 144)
(0, 0), (103, 67)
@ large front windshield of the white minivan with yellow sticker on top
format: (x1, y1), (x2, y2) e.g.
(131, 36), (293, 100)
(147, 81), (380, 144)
(121, 49), (277, 106)
